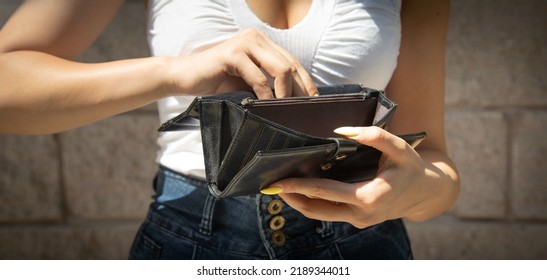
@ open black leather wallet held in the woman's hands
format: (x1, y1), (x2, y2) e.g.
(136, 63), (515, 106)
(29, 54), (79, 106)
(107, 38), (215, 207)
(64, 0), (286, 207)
(158, 84), (426, 198)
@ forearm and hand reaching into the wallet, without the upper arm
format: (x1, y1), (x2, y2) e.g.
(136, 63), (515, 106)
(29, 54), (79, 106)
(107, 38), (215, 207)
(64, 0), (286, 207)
(0, 30), (317, 134)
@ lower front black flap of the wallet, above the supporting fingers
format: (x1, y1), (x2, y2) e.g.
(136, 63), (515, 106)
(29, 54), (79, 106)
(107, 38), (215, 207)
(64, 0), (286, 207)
(209, 132), (426, 198)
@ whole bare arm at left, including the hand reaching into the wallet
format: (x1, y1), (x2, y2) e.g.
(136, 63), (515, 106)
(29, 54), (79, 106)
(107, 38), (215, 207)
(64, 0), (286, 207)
(0, 0), (315, 134)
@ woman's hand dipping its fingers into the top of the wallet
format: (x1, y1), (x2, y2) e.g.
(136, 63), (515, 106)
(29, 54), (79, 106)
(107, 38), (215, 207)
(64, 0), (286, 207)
(168, 29), (317, 98)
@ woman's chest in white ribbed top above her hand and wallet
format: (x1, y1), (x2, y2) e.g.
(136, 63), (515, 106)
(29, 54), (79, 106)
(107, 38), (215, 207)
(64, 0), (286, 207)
(149, 0), (400, 88)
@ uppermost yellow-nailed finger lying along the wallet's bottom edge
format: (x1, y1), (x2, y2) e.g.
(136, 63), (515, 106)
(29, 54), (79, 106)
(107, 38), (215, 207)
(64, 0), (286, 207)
(272, 178), (356, 204)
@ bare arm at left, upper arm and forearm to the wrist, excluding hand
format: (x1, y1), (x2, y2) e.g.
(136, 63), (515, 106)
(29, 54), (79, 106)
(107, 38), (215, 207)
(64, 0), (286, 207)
(0, 0), (167, 134)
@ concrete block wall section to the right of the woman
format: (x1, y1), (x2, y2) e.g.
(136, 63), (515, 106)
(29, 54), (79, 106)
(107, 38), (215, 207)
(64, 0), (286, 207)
(408, 0), (547, 259)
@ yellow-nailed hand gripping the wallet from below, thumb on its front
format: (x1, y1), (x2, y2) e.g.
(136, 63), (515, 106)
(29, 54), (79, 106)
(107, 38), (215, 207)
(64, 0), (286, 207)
(270, 127), (444, 228)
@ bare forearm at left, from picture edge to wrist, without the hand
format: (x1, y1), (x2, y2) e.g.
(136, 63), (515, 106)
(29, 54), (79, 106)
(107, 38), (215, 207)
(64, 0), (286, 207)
(0, 51), (172, 134)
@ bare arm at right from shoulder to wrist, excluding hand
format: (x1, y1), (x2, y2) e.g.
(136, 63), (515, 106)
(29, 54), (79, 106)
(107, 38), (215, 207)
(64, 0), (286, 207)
(387, 0), (459, 220)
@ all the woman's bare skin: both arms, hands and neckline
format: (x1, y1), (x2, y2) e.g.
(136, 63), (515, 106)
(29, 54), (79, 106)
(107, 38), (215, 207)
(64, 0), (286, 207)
(0, 0), (459, 228)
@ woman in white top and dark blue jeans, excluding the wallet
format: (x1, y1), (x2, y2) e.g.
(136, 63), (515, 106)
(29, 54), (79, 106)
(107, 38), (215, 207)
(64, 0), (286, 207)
(0, 0), (459, 259)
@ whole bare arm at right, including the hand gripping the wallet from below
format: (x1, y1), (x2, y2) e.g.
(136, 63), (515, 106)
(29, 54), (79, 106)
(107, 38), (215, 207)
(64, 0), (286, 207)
(272, 0), (459, 228)
